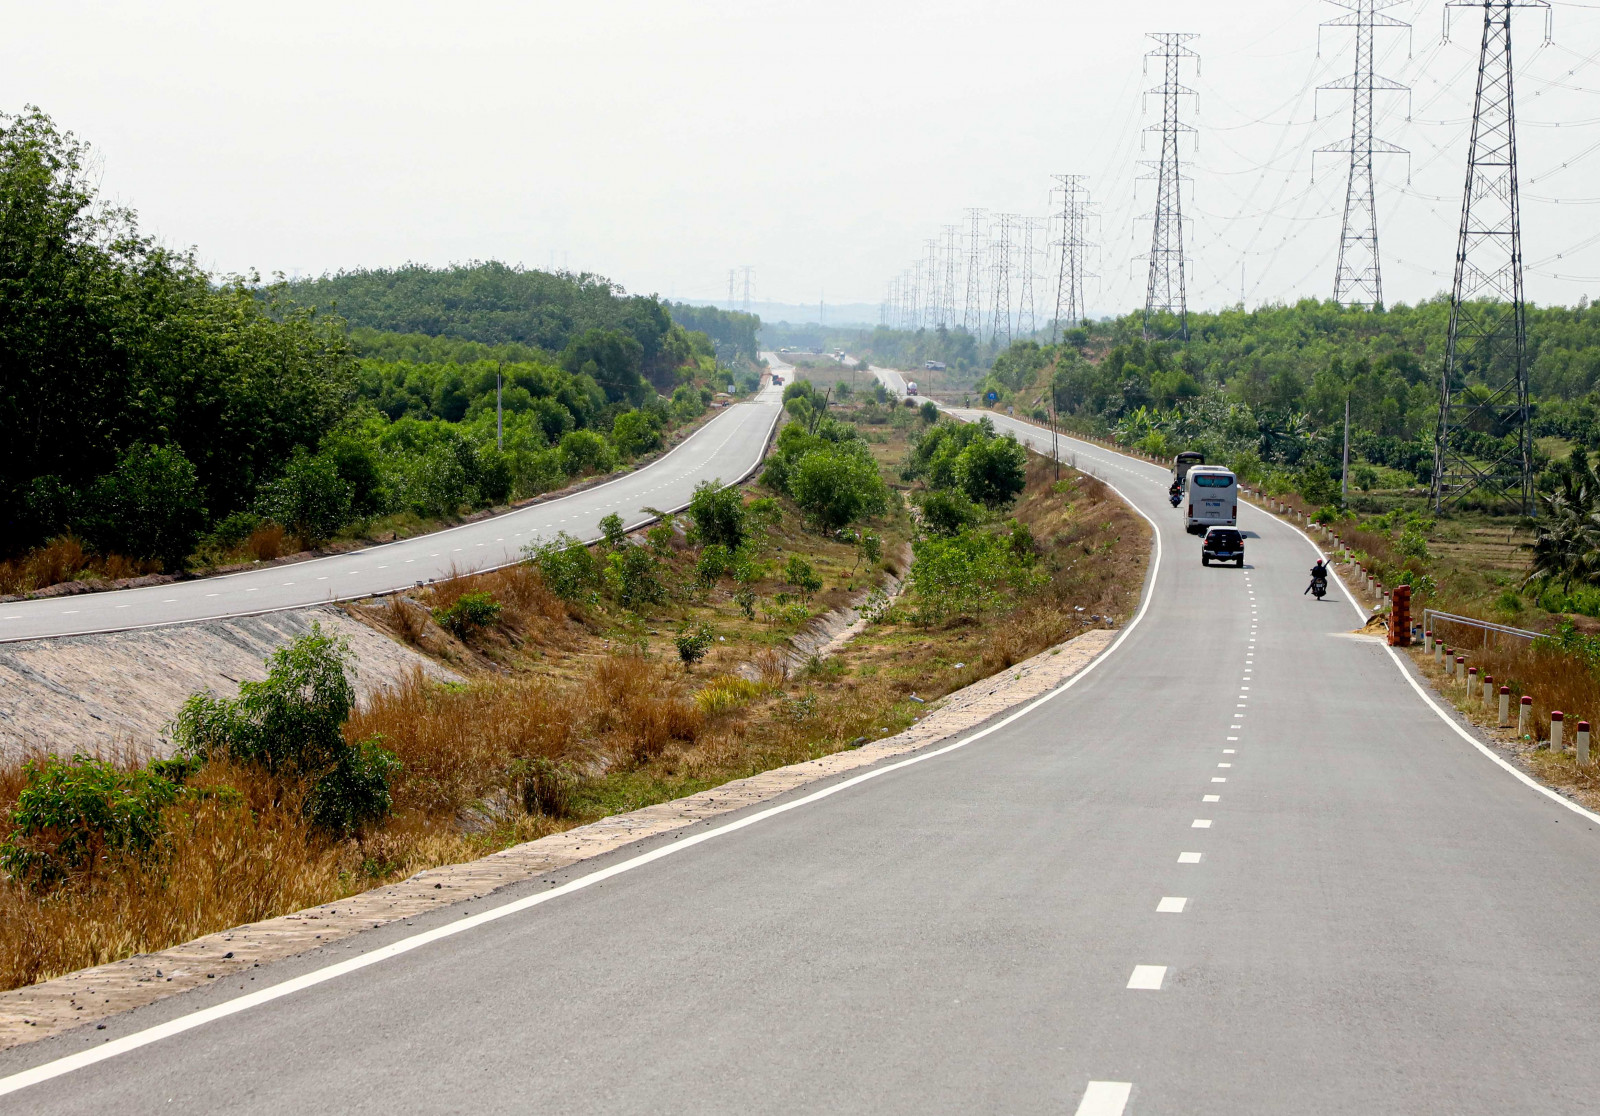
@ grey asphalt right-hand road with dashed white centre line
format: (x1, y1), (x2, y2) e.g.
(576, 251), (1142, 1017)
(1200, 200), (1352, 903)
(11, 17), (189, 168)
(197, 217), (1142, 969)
(0, 419), (1600, 1116)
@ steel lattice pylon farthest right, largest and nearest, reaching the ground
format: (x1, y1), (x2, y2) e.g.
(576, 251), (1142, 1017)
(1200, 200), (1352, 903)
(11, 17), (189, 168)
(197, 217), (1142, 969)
(1434, 0), (1549, 515)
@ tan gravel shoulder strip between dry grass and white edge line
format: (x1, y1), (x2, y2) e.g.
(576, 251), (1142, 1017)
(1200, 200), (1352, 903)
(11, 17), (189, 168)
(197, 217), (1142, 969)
(0, 628), (1117, 1049)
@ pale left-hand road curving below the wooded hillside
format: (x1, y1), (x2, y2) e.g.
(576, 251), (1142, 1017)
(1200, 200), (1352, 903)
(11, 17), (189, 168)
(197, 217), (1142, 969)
(0, 380), (786, 643)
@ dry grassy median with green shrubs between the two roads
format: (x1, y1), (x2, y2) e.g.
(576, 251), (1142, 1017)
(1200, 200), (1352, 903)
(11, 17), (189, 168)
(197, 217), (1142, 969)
(0, 392), (1149, 986)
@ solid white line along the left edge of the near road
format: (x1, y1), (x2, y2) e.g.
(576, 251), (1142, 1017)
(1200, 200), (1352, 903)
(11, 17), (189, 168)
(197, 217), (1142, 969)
(0, 425), (1162, 1097)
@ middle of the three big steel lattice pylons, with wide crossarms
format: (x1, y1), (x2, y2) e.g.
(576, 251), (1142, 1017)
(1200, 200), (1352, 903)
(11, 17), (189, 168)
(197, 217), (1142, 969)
(1317, 0), (1411, 309)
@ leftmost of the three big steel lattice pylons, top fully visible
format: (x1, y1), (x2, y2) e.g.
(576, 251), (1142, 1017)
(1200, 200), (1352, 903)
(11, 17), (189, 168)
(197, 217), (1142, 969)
(1142, 32), (1200, 341)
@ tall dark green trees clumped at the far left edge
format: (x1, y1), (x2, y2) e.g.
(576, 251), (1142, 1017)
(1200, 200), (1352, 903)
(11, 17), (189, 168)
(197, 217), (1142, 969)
(0, 110), (355, 556)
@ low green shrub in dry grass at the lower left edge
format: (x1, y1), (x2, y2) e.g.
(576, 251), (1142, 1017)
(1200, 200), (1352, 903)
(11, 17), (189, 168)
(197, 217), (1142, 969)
(0, 756), (179, 887)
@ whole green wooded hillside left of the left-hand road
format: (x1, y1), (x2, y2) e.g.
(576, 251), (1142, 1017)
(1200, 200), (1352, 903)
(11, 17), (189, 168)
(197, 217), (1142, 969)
(0, 112), (732, 571)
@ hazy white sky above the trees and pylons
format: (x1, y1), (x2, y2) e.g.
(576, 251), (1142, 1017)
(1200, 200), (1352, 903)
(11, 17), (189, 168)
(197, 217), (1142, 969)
(9, 0), (1600, 310)
